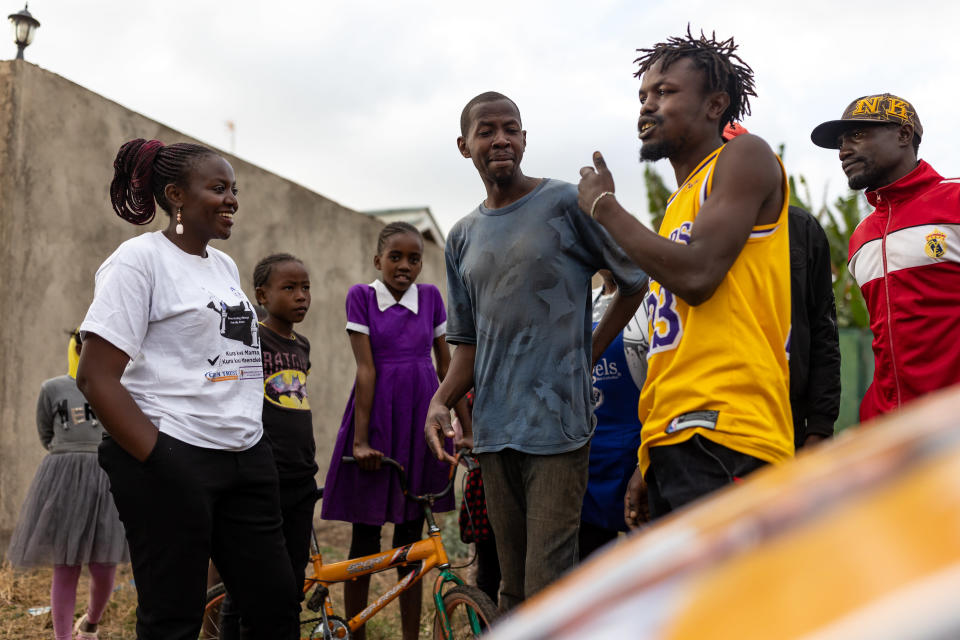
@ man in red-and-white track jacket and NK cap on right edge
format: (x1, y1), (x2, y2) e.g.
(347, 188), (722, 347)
(810, 93), (960, 420)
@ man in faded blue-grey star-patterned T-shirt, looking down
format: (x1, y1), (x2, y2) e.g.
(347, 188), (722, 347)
(425, 92), (647, 609)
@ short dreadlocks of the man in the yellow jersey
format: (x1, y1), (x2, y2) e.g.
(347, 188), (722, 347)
(633, 24), (757, 131)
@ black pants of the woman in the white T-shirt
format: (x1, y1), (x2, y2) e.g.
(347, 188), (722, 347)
(99, 433), (300, 640)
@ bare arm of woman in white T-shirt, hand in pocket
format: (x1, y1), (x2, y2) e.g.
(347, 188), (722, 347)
(77, 331), (160, 462)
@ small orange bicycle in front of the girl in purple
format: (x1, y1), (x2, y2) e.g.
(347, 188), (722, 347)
(202, 452), (497, 640)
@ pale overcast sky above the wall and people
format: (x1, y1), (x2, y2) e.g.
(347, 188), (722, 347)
(16, 0), (960, 231)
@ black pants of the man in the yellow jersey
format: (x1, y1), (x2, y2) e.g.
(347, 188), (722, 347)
(644, 434), (766, 519)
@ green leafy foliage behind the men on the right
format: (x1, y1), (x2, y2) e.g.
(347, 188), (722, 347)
(643, 150), (870, 328)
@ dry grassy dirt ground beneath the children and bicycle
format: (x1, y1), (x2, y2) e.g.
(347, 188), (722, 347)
(0, 510), (473, 640)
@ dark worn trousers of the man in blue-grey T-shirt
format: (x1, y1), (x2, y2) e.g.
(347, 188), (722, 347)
(477, 444), (590, 611)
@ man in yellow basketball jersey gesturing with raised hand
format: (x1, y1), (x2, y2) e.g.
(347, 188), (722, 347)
(579, 29), (793, 526)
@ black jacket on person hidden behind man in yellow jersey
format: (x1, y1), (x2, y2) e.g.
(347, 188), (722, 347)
(788, 207), (840, 448)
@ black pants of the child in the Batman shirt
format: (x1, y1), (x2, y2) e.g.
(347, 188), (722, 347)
(220, 476), (317, 640)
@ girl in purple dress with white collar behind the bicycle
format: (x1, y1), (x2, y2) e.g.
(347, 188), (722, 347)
(321, 222), (469, 640)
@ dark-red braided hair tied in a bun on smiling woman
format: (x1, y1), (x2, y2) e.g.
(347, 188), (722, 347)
(110, 138), (216, 224)
